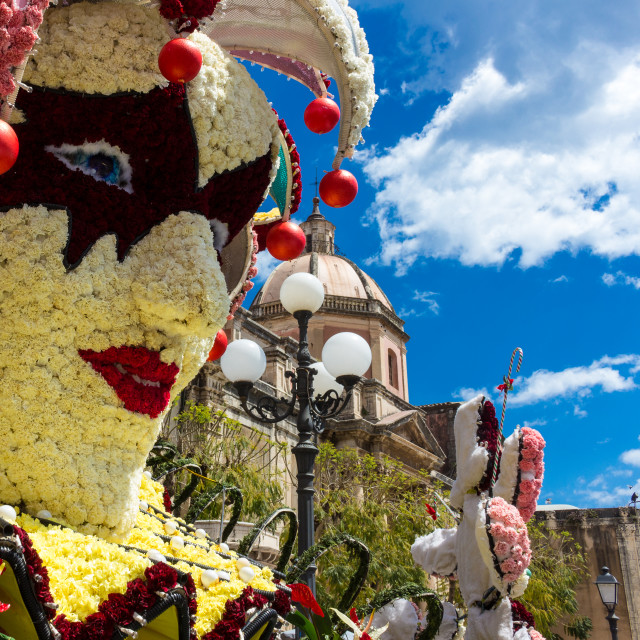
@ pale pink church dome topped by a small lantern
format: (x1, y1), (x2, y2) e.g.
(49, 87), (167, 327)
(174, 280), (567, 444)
(250, 198), (395, 315)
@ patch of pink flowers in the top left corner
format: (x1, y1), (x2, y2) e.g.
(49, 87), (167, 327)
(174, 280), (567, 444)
(0, 0), (49, 96)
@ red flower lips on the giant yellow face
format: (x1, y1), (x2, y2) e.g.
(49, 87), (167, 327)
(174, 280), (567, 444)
(78, 346), (180, 418)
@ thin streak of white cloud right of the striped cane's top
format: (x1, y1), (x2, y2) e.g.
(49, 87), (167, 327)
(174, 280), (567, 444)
(509, 354), (640, 404)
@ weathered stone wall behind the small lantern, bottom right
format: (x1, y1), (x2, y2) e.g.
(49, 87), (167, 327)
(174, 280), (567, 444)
(536, 507), (640, 640)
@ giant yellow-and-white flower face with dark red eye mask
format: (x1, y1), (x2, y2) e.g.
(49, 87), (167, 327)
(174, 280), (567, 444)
(0, 2), (278, 538)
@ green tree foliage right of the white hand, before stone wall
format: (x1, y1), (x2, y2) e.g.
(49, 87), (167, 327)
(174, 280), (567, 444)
(519, 520), (593, 640)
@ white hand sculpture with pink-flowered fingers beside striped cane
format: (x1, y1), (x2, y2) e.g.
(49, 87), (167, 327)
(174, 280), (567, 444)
(411, 396), (545, 640)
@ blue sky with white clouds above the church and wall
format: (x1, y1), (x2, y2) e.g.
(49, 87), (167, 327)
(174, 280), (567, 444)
(244, 0), (640, 507)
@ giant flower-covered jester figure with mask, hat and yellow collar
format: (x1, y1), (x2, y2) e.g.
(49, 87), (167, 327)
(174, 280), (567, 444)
(0, 0), (375, 640)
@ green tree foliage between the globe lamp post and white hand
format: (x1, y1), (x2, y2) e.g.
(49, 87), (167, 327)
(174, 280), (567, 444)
(315, 443), (453, 606)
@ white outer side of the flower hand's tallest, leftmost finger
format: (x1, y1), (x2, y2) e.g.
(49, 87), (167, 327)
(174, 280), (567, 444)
(450, 395), (489, 509)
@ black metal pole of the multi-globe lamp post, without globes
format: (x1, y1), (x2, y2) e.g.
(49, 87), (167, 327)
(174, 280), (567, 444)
(293, 311), (318, 595)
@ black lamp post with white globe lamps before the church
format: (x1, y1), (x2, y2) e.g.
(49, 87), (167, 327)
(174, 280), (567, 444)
(220, 273), (371, 594)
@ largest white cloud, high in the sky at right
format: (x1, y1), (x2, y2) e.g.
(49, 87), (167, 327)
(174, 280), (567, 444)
(363, 36), (640, 274)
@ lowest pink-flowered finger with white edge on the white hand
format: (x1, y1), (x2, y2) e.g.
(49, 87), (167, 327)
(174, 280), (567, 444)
(476, 497), (531, 593)
